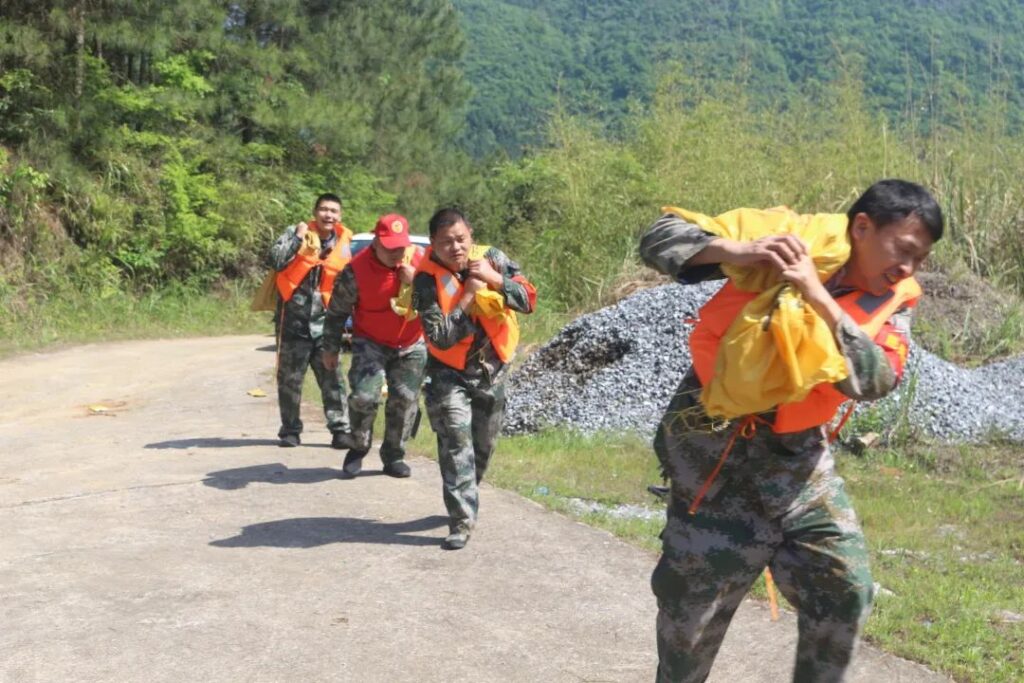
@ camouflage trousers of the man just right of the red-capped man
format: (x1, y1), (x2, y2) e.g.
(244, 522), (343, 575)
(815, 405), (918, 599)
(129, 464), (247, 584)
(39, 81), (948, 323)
(424, 368), (506, 529)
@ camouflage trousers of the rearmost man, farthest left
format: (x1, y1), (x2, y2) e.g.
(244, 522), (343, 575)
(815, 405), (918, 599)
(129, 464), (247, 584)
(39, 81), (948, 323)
(278, 337), (349, 436)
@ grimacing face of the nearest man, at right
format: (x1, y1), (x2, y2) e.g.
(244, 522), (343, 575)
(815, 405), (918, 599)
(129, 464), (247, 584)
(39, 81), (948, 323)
(847, 213), (932, 296)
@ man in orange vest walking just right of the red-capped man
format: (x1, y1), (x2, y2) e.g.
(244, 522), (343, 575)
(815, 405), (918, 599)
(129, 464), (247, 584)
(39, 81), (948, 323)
(413, 209), (537, 550)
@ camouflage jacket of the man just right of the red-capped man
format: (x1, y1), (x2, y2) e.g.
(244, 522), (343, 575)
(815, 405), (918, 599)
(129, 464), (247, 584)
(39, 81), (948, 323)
(413, 247), (532, 378)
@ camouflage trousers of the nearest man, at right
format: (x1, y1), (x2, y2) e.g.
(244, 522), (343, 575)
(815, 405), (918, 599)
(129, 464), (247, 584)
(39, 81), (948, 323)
(651, 380), (873, 683)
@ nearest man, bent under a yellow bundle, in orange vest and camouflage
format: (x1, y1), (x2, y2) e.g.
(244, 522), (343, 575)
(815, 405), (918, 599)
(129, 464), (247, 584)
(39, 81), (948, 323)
(640, 180), (943, 682)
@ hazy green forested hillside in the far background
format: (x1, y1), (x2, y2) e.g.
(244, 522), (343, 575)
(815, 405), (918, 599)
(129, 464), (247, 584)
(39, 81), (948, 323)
(455, 0), (1024, 154)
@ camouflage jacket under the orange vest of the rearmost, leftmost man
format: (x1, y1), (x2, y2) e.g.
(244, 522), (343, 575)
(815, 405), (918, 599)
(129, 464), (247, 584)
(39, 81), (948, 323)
(267, 225), (338, 339)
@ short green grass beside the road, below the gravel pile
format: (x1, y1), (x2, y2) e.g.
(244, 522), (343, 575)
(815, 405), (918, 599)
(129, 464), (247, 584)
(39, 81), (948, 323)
(411, 413), (1024, 683)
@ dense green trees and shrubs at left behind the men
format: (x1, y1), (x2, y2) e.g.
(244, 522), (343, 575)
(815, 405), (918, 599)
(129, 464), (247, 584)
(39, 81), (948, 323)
(0, 0), (466, 291)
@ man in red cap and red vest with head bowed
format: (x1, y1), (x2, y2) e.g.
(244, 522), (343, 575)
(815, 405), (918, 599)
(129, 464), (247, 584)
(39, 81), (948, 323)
(324, 213), (427, 478)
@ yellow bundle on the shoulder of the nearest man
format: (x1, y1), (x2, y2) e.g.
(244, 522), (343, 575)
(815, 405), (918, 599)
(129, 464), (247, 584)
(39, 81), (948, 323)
(663, 207), (850, 418)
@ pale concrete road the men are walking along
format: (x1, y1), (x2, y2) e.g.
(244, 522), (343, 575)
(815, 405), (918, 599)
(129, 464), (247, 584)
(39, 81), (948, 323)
(0, 337), (947, 683)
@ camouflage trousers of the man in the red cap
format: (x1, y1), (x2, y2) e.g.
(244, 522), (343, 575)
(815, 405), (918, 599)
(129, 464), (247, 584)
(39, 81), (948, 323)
(348, 337), (427, 465)
